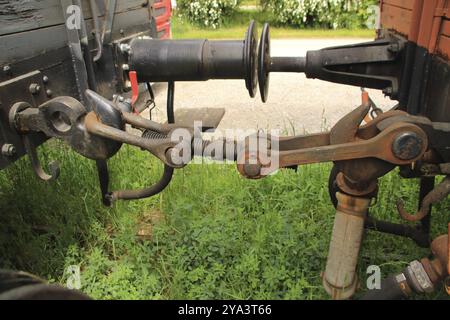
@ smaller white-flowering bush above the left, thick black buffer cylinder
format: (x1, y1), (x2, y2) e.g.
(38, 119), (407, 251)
(177, 0), (240, 29)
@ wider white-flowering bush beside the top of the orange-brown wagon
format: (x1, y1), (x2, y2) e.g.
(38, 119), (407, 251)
(261, 0), (377, 29)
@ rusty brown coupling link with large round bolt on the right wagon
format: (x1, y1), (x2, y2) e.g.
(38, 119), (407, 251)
(238, 105), (428, 180)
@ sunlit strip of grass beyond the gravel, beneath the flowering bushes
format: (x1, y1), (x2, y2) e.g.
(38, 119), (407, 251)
(172, 10), (375, 39)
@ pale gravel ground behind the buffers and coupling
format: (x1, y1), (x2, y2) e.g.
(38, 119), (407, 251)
(146, 39), (395, 134)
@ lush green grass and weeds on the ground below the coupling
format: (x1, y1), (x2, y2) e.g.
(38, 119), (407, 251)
(0, 142), (450, 299)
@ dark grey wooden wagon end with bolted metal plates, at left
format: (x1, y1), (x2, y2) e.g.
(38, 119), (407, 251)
(0, 0), (171, 168)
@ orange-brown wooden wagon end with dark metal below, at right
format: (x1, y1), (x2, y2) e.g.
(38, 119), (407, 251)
(381, 0), (450, 122)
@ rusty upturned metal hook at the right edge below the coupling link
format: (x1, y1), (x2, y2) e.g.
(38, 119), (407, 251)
(397, 176), (450, 222)
